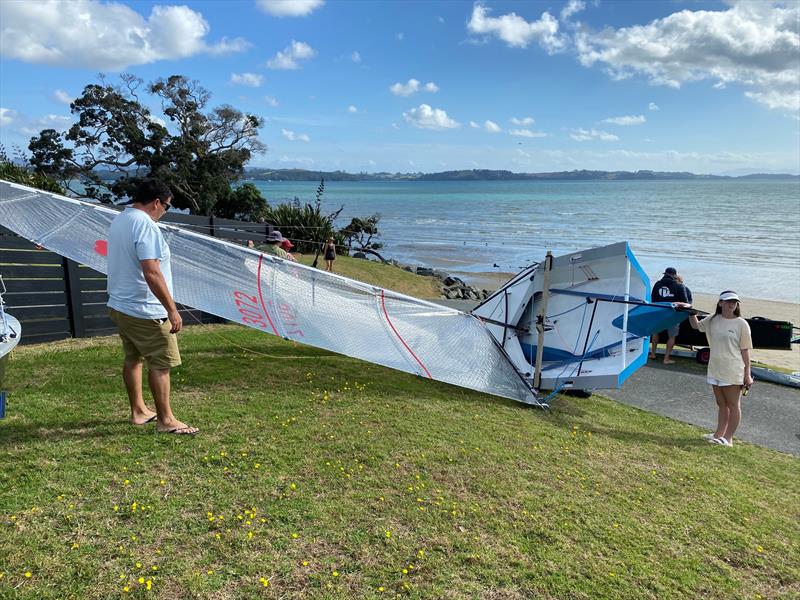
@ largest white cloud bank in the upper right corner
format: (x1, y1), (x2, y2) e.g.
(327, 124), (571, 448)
(575, 2), (800, 112)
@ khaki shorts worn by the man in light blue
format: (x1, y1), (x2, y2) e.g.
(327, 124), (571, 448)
(108, 308), (181, 369)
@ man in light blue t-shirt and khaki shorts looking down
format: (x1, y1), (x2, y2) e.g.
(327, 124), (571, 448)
(108, 179), (198, 435)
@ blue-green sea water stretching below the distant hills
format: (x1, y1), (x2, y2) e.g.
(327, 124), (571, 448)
(250, 181), (800, 302)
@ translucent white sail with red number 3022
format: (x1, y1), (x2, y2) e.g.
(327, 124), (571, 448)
(0, 180), (540, 405)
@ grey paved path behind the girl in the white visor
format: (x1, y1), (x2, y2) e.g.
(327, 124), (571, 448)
(437, 300), (800, 456)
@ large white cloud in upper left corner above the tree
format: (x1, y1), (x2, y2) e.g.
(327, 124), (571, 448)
(0, 0), (248, 70)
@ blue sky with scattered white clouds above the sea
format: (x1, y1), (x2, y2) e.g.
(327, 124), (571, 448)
(0, 0), (800, 175)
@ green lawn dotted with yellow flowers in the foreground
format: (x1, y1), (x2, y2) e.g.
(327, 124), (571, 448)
(0, 326), (800, 599)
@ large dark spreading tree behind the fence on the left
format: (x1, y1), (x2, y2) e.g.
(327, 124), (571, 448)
(28, 74), (266, 219)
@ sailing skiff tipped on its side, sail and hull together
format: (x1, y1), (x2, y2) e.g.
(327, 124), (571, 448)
(0, 180), (688, 406)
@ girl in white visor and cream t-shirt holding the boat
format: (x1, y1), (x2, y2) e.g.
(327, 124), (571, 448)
(684, 290), (753, 446)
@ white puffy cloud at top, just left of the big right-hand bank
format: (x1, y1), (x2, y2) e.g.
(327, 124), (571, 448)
(467, 2), (566, 54)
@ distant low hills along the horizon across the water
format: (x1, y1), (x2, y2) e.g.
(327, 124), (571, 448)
(245, 168), (800, 181)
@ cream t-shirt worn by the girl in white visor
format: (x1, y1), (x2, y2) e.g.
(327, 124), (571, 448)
(698, 315), (753, 385)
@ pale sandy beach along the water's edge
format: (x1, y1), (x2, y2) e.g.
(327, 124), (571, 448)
(454, 273), (800, 371)
